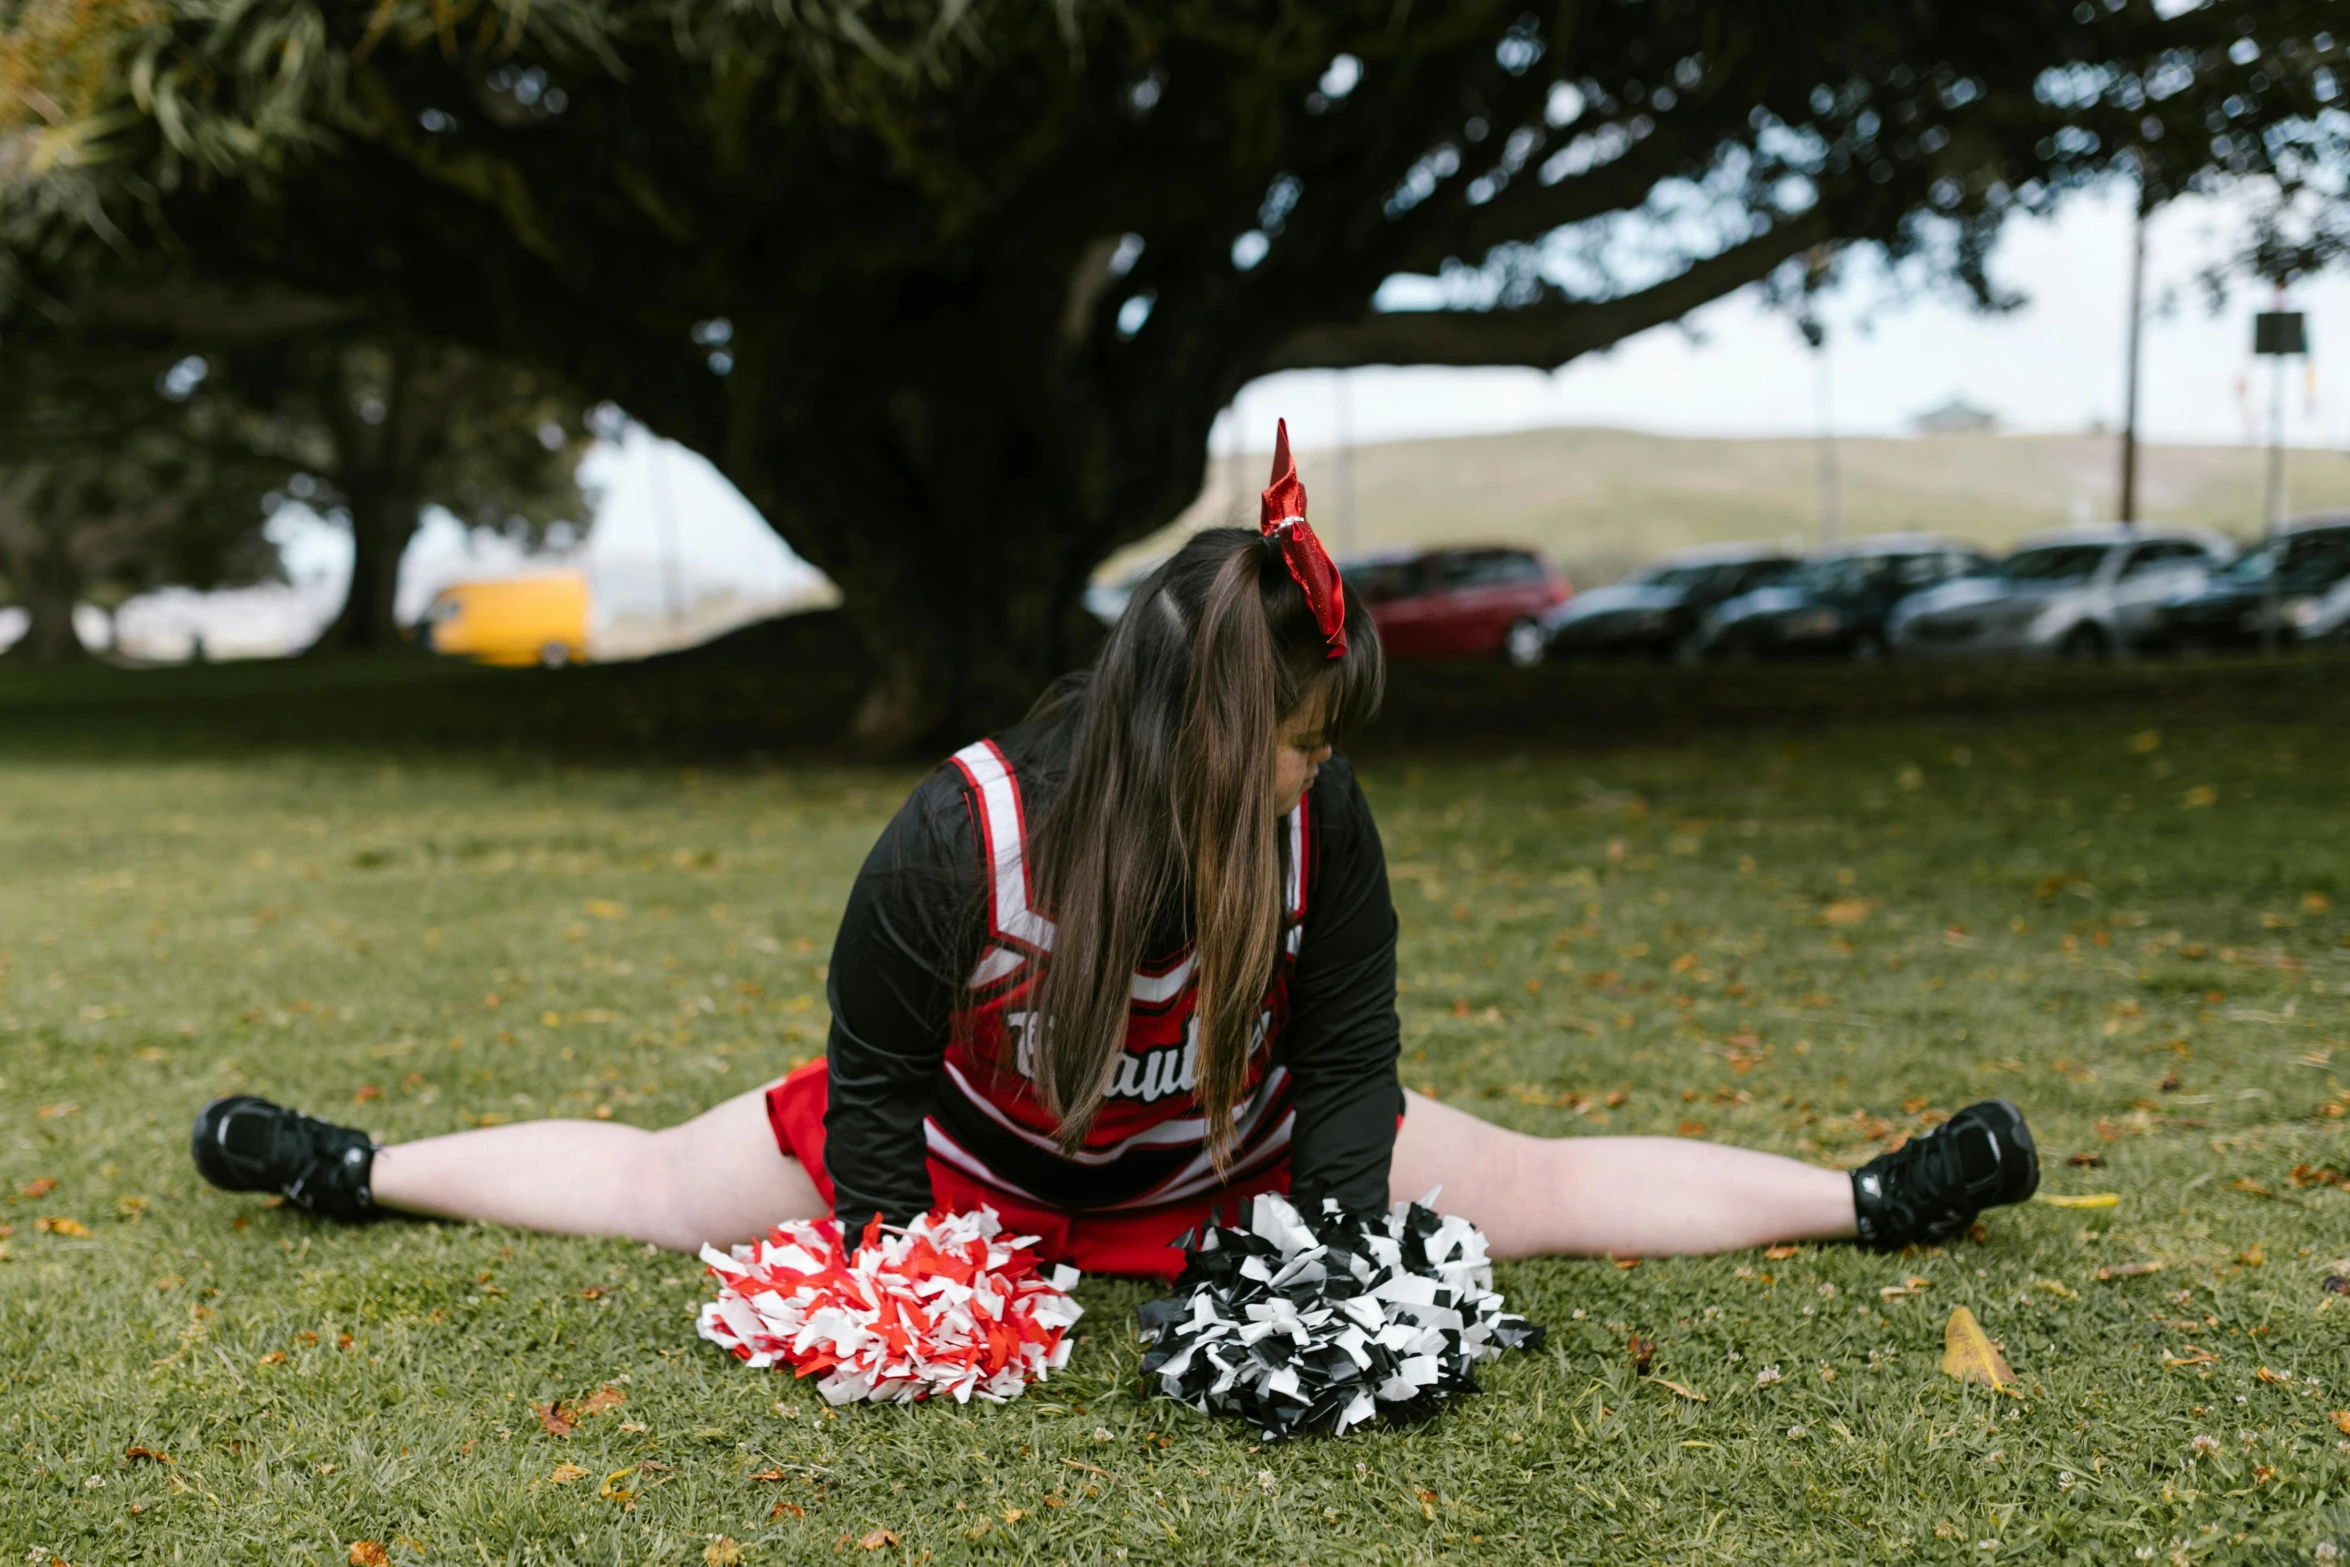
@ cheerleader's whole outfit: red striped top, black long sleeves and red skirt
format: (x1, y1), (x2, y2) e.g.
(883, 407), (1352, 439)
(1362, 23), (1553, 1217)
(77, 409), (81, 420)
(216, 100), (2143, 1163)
(766, 721), (1403, 1278)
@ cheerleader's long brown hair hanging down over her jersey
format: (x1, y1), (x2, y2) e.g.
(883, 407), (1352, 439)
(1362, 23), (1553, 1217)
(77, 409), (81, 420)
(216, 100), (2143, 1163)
(1029, 529), (1387, 1170)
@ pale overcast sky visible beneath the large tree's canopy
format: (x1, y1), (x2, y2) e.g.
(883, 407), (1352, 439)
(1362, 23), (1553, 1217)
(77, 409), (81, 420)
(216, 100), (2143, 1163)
(307, 176), (2350, 604)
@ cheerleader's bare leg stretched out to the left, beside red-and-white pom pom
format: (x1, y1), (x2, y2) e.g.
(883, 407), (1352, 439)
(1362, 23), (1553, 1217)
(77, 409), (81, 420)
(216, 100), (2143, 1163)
(374, 1088), (825, 1252)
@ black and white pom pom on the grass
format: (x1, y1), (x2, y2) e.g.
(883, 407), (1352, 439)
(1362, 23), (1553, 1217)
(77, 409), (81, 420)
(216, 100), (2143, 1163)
(1135, 1193), (1542, 1440)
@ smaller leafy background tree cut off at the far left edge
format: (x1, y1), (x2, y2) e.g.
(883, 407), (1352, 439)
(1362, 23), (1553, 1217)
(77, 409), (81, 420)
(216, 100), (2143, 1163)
(0, 355), (287, 660)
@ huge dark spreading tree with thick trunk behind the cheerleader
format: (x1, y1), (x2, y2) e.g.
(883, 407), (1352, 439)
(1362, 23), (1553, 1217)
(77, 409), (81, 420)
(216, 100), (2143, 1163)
(0, 0), (2341, 742)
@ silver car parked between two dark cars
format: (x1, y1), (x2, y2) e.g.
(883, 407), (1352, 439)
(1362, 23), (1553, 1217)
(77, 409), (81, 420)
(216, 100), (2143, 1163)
(1887, 522), (2235, 658)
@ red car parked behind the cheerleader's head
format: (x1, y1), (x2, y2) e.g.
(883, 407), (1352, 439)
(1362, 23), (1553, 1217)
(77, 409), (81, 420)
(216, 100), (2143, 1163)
(1342, 547), (1575, 670)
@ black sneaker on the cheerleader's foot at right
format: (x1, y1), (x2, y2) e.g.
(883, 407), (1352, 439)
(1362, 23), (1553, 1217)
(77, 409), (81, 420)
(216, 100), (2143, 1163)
(1852, 1099), (2040, 1252)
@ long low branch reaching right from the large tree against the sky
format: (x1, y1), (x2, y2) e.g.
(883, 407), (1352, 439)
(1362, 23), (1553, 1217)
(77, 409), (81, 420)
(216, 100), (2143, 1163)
(1257, 209), (1833, 374)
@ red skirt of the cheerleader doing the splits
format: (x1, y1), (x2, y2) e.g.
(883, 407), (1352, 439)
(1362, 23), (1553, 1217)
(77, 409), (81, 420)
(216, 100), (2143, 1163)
(766, 1060), (1290, 1280)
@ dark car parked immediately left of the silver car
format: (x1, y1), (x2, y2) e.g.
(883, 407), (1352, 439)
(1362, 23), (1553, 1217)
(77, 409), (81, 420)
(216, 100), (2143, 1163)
(1697, 533), (1990, 663)
